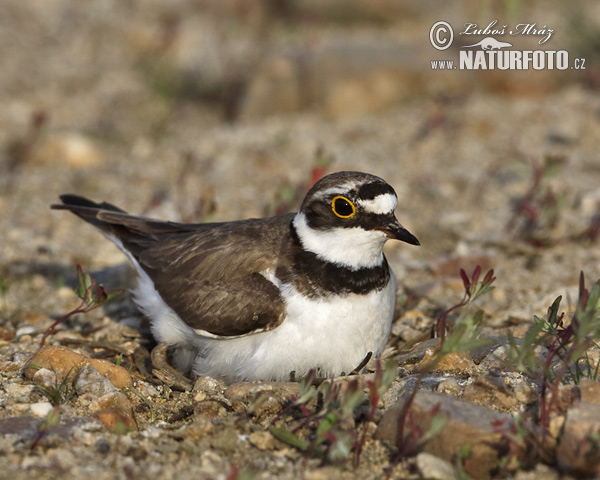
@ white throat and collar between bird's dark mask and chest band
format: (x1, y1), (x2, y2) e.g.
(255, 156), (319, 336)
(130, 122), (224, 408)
(293, 212), (387, 271)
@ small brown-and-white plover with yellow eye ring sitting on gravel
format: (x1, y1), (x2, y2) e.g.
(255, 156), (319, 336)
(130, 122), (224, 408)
(51, 171), (419, 383)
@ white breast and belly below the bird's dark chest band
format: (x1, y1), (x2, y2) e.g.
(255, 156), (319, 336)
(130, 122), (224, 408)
(193, 274), (396, 380)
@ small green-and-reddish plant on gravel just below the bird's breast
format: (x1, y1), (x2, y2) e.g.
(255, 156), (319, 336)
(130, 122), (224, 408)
(269, 361), (396, 466)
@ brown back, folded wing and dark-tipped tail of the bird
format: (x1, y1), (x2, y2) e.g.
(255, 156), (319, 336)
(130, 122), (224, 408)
(53, 195), (292, 336)
